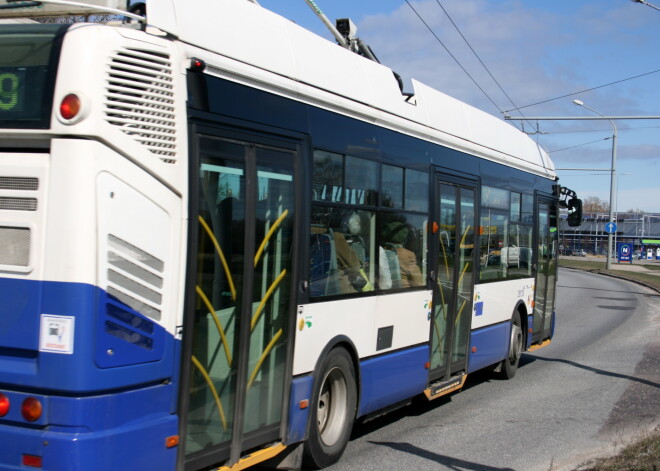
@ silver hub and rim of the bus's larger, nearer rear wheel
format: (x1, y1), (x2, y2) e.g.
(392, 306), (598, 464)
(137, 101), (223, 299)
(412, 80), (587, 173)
(316, 368), (348, 446)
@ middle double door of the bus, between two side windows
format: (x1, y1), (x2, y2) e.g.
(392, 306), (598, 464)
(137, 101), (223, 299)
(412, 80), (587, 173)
(429, 176), (477, 381)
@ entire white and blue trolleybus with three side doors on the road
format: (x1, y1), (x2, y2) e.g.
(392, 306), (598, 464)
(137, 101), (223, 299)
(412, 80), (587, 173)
(0, 0), (580, 471)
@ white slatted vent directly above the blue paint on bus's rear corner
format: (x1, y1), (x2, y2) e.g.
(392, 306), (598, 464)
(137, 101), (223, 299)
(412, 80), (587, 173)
(107, 234), (165, 320)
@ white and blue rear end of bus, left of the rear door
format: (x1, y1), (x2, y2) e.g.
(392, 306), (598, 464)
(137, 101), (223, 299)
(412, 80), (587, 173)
(0, 24), (184, 470)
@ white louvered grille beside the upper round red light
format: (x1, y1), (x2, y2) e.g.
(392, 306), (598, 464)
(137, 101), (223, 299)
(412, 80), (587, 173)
(105, 49), (176, 164)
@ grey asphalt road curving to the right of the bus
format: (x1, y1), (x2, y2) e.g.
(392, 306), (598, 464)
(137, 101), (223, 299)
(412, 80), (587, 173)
(328, 269), (660, 471)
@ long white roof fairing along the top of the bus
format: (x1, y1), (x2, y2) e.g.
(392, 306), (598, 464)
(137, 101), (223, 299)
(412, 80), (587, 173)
(147, 0), (555, 179)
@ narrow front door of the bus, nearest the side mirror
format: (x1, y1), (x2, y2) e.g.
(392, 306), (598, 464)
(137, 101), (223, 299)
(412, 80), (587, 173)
(532, 196), (559, 344)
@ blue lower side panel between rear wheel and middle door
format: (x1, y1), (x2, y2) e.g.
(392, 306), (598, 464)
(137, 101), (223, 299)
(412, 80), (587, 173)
(357, 345), (429, 417)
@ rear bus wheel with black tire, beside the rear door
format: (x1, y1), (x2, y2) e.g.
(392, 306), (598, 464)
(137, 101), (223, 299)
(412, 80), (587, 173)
(303, 348), (357, 469)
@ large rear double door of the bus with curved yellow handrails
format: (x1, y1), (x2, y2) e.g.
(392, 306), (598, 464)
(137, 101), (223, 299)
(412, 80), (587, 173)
(179, 126), (301, 470)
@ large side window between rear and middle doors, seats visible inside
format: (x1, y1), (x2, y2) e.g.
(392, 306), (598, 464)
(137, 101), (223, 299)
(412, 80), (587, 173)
(310, 150), (428, 298)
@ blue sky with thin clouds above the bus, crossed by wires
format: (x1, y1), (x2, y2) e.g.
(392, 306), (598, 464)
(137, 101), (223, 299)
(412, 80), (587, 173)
(258, 0), (660, 213)
